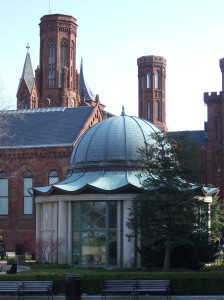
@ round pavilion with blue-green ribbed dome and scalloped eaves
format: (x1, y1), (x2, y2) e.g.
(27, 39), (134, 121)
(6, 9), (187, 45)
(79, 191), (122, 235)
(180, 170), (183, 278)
(32, 112), (217, 267)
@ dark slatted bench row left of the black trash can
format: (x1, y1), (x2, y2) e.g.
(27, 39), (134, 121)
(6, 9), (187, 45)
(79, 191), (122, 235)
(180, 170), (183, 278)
(0, 281), (53, 299)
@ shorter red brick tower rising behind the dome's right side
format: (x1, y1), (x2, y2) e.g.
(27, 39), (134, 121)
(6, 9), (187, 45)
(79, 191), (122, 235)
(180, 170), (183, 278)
(137, 55), (168, 132)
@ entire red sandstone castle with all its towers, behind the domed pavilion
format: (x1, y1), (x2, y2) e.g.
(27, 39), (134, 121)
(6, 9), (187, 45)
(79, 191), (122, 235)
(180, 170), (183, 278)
(0, 14), (224, 251)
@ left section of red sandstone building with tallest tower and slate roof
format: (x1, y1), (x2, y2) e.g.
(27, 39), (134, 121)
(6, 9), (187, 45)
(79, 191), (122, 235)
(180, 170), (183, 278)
(0, 14), (110, 251)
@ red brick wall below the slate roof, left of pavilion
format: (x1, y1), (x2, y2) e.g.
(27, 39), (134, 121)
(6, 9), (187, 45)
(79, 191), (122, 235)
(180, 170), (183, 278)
(0, 147), (72, 251)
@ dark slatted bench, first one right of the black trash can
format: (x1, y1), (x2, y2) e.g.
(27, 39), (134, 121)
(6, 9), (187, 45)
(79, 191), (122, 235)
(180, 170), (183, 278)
(102, 280), (137, 300)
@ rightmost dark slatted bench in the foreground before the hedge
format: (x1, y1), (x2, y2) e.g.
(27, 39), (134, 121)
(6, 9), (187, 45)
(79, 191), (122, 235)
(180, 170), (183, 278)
(135, 280), (170, 300)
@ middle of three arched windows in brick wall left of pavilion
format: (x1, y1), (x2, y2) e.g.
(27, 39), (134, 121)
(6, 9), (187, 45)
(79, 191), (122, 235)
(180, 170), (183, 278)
(23, 171), (33, 215)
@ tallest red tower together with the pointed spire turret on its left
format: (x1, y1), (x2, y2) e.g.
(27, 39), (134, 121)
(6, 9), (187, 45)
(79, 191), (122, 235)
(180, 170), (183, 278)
(17, 14), (79, 109)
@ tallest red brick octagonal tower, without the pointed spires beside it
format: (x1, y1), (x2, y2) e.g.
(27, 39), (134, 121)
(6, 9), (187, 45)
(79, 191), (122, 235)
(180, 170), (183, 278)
(39, 14), (77, 107)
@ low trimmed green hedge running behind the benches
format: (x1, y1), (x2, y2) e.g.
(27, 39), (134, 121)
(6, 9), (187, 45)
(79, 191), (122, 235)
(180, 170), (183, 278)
(0, 270), (224, 295)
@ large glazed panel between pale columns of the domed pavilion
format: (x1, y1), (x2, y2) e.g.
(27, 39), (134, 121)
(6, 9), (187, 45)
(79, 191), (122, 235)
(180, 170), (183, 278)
(72, 201), (117, 266)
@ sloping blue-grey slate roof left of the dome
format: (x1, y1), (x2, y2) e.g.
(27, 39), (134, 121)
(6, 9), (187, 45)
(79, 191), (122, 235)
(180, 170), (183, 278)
(0, 106), (94, 148)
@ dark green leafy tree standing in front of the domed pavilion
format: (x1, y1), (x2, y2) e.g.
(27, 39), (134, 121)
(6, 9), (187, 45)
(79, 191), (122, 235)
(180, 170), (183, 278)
(127, 132), (219, 270)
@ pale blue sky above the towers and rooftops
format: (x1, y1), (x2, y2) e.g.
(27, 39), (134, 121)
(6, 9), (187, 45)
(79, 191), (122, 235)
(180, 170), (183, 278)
(0, 0), (224, 130)
